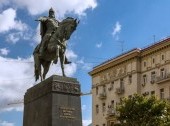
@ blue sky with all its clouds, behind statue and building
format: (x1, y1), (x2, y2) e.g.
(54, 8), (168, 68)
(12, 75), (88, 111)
(0, 0), (170, 126)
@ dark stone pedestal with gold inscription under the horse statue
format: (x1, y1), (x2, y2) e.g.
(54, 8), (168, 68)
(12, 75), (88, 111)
(23, 75), (82, 126)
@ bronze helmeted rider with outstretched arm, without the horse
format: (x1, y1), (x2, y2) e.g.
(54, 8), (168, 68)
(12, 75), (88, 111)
(36, 8), (71, 64)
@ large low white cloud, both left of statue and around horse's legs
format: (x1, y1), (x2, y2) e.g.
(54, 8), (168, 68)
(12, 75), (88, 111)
(0, 50), (77, 111)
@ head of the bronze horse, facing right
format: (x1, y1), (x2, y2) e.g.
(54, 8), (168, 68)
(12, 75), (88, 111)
(60, 17), (79, 40)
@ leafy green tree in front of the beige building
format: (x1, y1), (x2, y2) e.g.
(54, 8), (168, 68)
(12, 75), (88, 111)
(117, 94), (170, 126)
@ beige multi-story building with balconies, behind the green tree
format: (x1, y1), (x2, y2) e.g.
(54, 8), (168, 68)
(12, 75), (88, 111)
(89, 38), (170, 126)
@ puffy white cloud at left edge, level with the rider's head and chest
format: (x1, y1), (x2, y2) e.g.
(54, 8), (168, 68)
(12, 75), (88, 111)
(0, 8), (27, 32)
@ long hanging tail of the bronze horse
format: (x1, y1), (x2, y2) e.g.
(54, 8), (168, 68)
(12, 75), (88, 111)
(34, 53), (42, 81)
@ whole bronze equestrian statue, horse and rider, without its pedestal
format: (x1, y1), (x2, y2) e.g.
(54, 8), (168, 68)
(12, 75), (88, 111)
(33, 8), (79, 81)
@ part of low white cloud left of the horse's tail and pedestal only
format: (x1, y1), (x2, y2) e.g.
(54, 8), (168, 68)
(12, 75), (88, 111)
(0, 57), (34, 111)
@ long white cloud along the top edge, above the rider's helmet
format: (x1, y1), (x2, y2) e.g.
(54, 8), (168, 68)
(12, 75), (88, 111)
(0, 0), (97, 17)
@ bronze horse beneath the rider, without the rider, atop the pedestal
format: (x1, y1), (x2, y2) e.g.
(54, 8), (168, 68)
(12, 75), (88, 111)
(33, 17), (79, 81)
